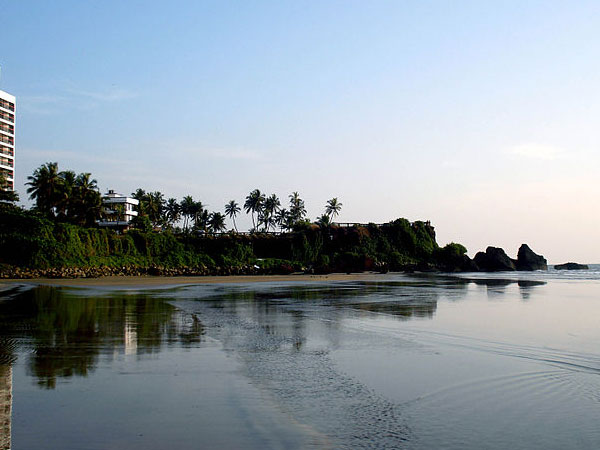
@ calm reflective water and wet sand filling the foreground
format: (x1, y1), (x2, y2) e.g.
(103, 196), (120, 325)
(0, 266), (600, 449)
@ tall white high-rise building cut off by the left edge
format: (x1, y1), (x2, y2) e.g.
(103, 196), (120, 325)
(0, 91), (16, 190)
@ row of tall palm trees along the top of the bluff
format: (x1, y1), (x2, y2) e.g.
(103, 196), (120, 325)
(11, 162), (342, 233)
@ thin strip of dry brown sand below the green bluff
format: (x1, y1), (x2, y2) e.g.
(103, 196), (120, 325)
(0, 273), (382, 287)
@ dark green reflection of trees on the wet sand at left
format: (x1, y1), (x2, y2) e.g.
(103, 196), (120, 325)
(0, 287), (203, 389)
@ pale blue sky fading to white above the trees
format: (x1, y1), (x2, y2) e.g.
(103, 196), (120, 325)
(0, 0), (600, 263)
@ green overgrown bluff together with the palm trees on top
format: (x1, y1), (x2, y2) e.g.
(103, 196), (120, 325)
(0, 163), (466, 273)
